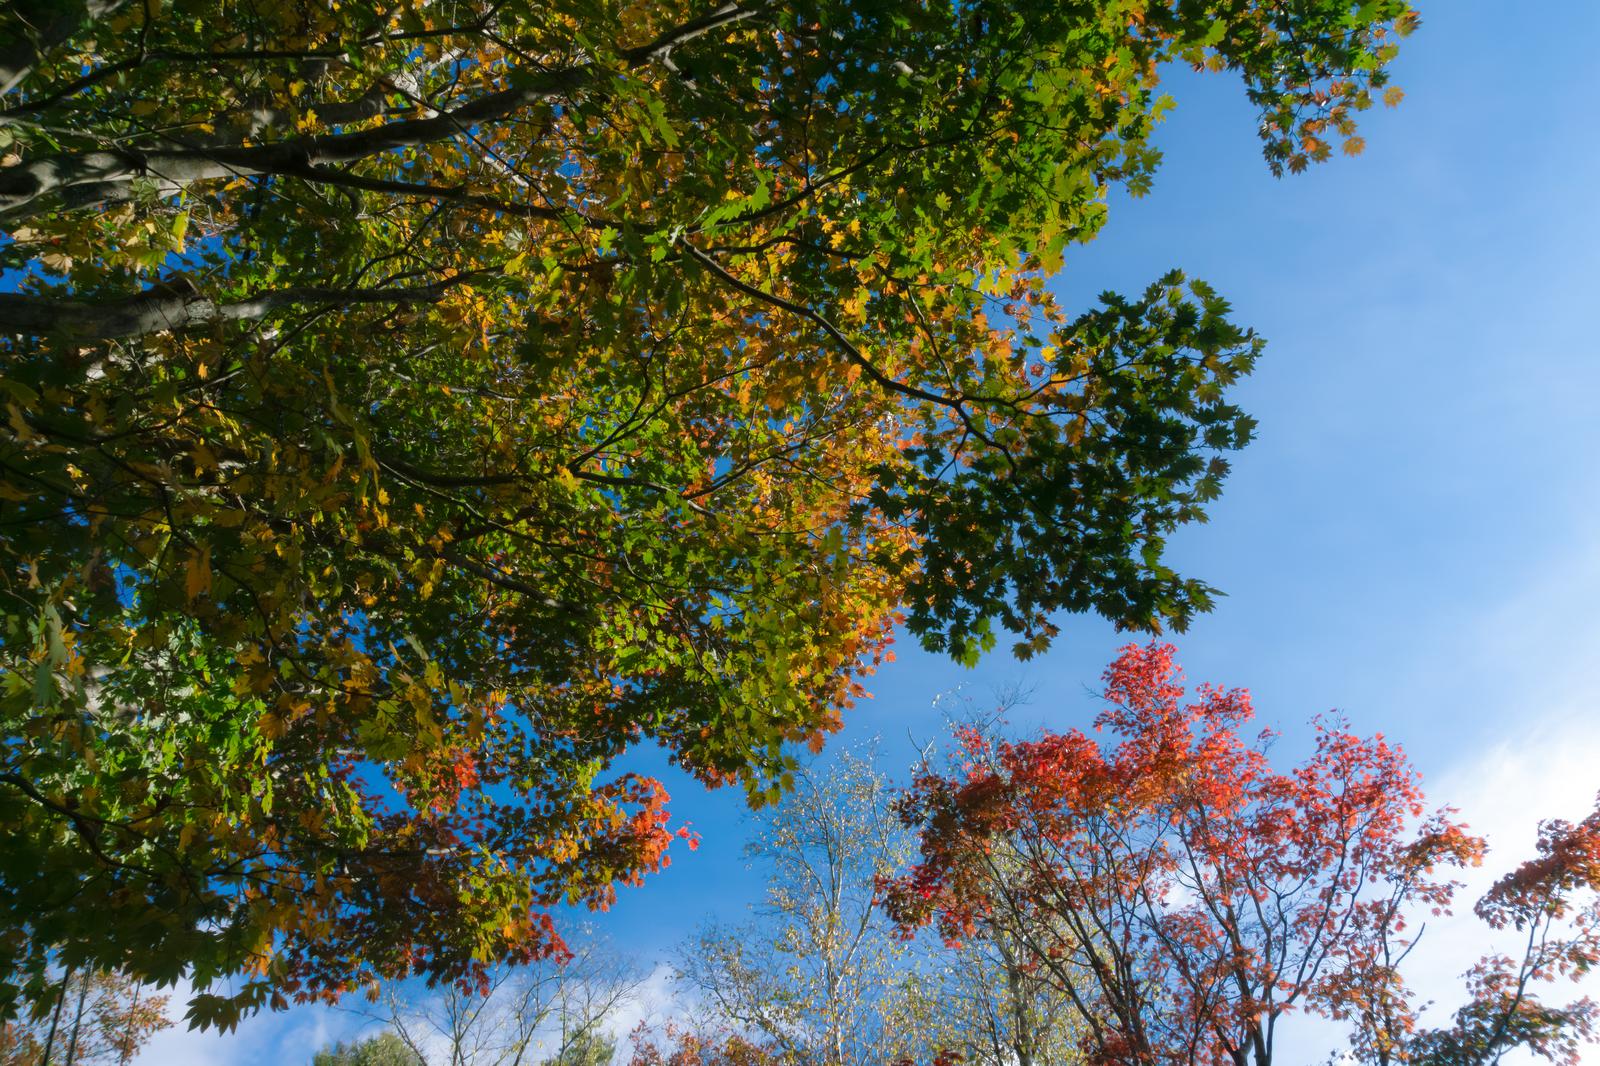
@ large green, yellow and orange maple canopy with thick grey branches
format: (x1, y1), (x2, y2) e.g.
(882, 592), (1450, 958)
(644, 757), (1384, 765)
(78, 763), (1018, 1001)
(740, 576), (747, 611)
(0, 0), (1414, 1024)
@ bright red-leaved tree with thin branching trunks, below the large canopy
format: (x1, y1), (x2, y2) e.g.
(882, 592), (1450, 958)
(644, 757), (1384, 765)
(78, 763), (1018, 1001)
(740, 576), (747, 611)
(880, 645), (1483, 1066)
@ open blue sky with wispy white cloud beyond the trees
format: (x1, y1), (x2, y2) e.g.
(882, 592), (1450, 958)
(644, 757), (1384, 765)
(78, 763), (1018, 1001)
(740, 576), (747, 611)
(150, 0), (1600, 1064)
